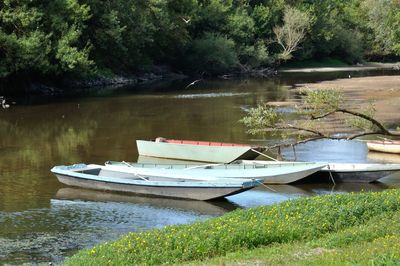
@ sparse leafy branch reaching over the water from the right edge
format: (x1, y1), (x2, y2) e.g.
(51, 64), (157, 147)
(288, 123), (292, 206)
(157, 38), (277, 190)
(240, 89), (400, 150)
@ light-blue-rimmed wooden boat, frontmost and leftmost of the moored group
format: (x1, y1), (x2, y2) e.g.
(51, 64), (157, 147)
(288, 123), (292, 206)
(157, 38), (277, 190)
(51, 164), (260, 200)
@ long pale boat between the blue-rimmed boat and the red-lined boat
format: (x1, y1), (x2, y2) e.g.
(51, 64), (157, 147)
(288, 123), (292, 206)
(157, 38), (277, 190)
(106, 161), (326, 184)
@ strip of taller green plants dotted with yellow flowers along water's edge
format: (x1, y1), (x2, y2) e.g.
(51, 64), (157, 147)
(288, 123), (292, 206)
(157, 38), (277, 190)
(65, 189), (400, 265)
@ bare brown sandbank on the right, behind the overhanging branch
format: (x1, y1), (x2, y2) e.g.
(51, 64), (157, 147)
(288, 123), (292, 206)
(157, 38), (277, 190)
(262, 75), (400, 134)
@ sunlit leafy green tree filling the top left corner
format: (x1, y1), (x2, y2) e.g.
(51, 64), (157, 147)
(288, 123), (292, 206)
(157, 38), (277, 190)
(0, 0), (93, 77)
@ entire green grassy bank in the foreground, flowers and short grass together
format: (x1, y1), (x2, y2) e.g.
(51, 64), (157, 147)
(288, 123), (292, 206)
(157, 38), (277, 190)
(66, 190), (400, 265)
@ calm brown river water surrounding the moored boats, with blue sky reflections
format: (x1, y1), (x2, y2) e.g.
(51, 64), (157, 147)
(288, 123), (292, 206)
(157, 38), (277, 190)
(0, 70), (400, 264)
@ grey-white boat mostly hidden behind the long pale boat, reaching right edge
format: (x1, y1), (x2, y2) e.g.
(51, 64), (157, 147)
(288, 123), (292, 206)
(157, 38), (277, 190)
(238, 160), (400, 183)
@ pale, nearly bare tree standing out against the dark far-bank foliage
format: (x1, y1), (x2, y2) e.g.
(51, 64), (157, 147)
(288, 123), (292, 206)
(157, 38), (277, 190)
(274, 7), (310, 60)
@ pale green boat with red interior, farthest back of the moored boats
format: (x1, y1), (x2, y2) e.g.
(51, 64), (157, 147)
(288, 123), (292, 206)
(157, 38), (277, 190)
(136, 138), (265, 163)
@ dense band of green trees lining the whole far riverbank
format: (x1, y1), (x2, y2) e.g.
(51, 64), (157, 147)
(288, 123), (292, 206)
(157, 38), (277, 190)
(0, 0), (400, 81)
